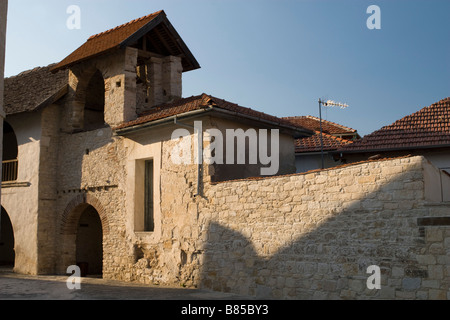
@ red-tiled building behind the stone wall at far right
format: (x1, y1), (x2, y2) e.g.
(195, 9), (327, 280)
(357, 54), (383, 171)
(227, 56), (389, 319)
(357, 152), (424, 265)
(333, 97), (450, 201)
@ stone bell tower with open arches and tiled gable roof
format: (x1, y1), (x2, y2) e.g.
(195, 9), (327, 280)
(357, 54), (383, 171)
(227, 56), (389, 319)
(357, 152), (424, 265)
(52, 11), (200, 131)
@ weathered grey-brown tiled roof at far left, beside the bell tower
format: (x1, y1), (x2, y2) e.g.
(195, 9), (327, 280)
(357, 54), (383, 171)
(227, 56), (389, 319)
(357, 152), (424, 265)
(4, 65), (69, 115)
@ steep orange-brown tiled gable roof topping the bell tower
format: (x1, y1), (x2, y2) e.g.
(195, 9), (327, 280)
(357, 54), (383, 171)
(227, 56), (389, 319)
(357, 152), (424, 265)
(54, 10), (199, 70)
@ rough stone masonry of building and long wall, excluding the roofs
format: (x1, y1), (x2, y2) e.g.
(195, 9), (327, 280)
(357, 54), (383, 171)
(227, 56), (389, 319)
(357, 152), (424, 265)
(2, 10), (450, 299)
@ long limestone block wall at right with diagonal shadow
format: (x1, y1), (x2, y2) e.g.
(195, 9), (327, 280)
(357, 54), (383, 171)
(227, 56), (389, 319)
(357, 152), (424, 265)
(196, 157), (450, 299)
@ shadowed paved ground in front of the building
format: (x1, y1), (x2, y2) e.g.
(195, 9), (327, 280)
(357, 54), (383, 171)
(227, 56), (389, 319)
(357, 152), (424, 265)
(0, 269), (253, 300)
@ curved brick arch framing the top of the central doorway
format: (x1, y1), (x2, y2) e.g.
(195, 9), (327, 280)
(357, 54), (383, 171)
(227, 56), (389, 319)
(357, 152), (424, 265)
(60, 193), (109, 235)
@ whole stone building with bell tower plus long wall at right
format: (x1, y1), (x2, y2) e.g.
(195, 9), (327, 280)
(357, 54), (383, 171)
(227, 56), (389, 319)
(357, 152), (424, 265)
(0, 11), (450, 299)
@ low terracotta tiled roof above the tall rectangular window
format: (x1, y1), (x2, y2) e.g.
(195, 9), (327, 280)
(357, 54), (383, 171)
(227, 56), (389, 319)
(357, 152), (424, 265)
(115, 93), (312, 135)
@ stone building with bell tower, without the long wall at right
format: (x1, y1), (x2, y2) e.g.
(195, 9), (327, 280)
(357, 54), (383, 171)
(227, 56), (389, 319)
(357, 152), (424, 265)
(2, 11), (311, 282)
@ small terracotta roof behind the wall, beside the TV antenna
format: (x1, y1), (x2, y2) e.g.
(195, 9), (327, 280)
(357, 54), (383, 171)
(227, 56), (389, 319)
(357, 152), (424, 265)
(295, 131), (353, 153)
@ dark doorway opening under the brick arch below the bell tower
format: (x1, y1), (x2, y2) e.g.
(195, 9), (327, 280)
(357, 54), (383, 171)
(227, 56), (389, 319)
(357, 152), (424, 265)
(76, 205), (103, 276)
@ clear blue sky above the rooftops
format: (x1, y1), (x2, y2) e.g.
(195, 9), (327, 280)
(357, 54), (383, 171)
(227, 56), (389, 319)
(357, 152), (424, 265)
(5, 0), (450, 135)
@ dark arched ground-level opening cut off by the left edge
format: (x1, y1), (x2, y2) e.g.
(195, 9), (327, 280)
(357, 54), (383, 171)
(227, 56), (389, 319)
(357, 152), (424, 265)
(0, 207), (15, 268)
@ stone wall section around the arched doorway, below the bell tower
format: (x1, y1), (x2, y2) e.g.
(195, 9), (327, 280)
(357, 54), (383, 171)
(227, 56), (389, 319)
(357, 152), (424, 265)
(55, 128), (133, 278)
